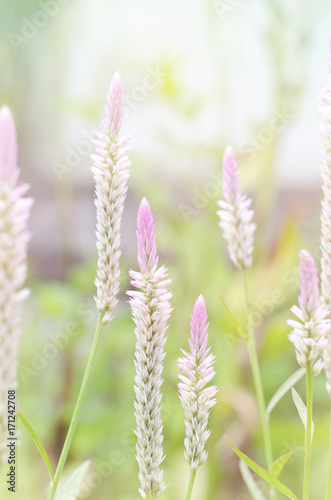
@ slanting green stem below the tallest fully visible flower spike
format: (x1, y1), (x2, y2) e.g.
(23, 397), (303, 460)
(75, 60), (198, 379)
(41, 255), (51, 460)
(48, 314), (103, 500)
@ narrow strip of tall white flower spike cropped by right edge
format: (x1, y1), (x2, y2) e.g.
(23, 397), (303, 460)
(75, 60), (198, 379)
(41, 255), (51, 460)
(320, 37), (331, 397)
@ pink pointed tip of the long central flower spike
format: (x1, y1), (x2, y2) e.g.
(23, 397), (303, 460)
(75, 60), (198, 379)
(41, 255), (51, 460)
(137, 198), (159, 274)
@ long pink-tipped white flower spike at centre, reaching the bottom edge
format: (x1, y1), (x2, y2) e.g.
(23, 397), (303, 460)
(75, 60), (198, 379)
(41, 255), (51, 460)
(127, 198), (172, 499)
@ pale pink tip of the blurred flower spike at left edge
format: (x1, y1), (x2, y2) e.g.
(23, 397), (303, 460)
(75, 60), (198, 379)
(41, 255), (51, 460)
(0, 106), (19, 186)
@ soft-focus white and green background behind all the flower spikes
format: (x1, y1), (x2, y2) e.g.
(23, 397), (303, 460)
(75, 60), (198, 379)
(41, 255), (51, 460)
(0, 0), (331, 500)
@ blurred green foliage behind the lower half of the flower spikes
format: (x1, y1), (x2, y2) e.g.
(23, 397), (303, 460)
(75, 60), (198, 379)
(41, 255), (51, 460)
(2, 167), (328, 500)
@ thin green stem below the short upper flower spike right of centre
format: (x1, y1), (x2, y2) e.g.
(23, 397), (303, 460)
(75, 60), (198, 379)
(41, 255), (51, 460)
(241, 268), (273, 470)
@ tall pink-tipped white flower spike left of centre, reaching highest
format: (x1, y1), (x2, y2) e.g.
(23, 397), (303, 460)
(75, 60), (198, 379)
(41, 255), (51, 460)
(92, 72), (131, 325)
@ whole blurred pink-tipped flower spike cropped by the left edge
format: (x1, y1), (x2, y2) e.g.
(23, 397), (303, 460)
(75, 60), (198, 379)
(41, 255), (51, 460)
(0, 106), (33, 463)
